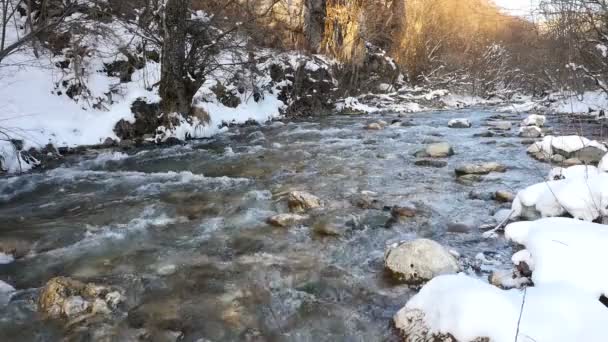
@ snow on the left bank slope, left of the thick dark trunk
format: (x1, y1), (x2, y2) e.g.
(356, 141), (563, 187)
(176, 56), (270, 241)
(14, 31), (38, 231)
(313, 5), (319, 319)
(0, 8), (160, 172)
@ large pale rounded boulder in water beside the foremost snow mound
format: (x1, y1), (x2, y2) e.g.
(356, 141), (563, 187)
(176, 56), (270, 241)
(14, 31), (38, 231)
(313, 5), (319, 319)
(384, 239), (460, 285)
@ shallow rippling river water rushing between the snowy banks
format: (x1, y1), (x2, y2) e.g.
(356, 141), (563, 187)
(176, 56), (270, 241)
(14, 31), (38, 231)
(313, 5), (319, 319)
(0, 109), (548, 342)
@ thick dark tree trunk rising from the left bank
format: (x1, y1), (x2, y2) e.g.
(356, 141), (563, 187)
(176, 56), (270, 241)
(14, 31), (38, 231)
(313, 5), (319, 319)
(159, 0), (194, 114)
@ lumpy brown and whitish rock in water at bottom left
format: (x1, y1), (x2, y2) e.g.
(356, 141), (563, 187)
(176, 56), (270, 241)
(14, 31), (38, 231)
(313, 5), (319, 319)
(38, 277), (122, 320)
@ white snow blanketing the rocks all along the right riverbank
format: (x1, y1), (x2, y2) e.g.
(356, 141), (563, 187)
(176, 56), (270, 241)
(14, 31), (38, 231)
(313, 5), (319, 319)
(394, 137), (608, 342)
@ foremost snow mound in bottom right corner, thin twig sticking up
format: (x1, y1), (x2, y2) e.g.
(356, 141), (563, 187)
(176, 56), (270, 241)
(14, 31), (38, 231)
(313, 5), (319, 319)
(395, 274), (608, 342)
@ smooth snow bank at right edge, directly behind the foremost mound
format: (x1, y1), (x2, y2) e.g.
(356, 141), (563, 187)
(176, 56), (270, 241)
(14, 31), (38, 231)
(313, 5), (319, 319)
(505, 217), (608, 296)
